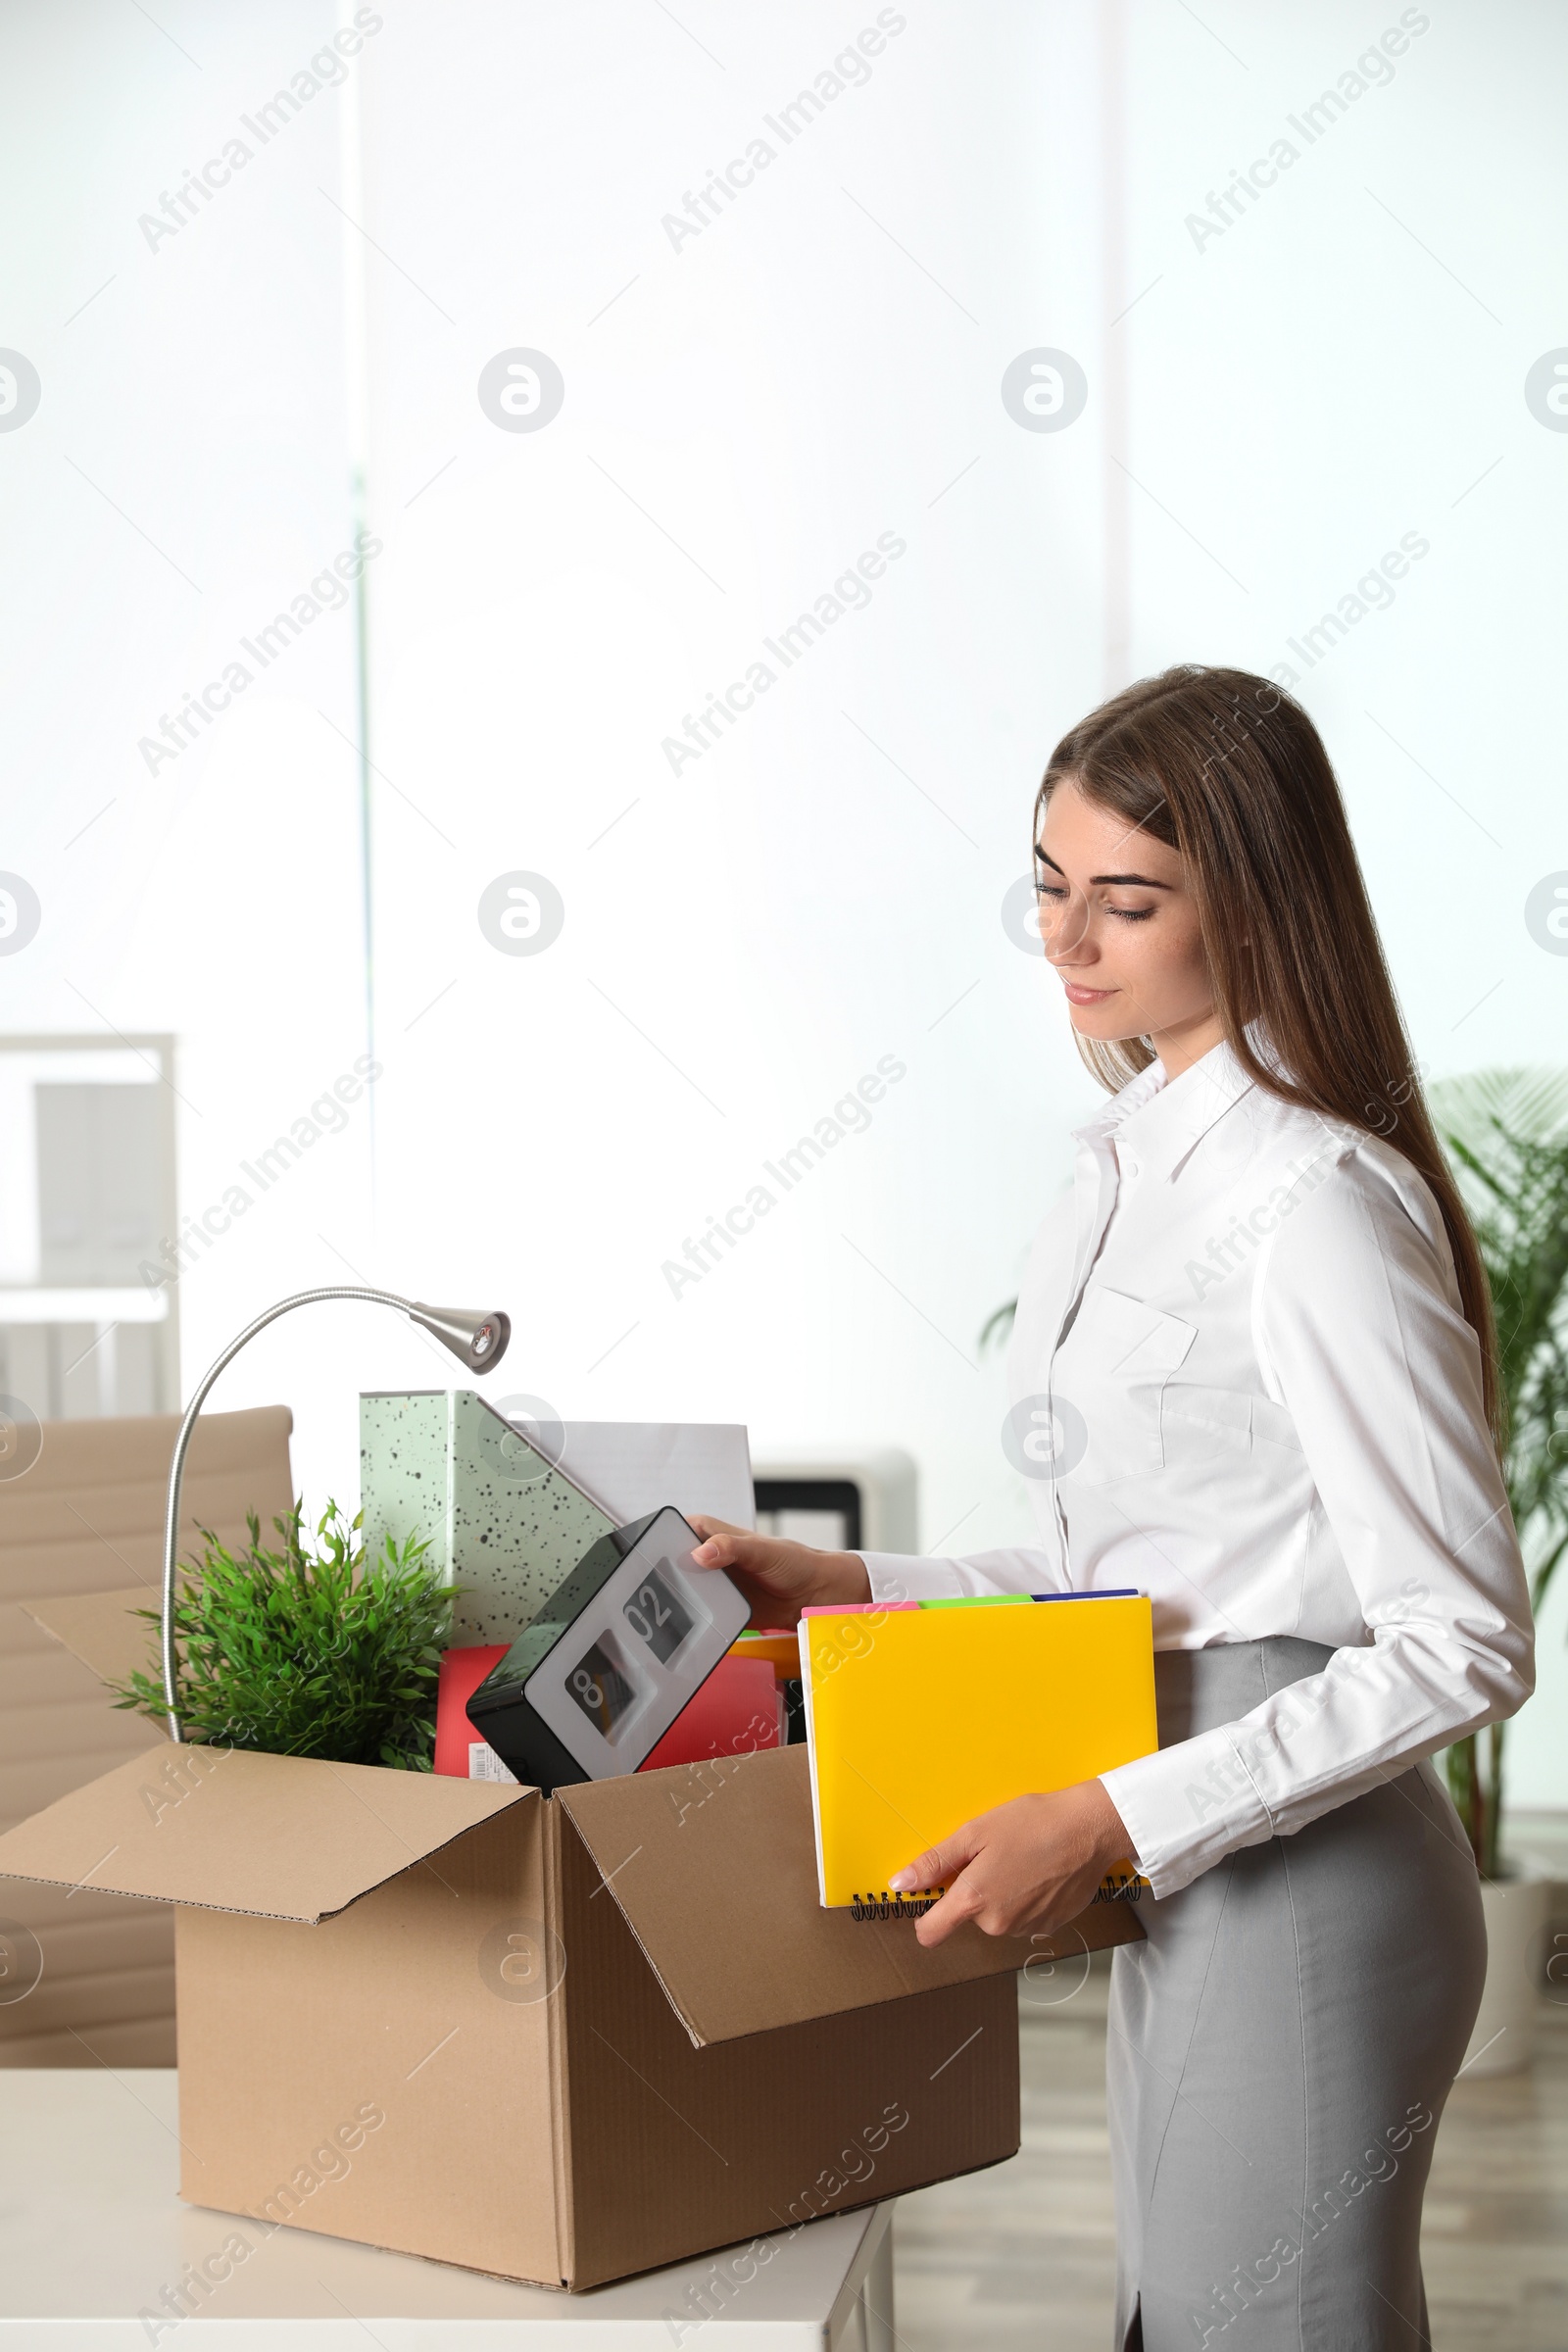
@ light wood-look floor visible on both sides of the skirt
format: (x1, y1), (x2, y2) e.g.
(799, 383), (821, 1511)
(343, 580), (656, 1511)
(896, 1974), (1568, 2352)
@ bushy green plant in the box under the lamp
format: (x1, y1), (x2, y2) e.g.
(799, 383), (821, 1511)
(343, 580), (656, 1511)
(113, 1503), (456, 1771)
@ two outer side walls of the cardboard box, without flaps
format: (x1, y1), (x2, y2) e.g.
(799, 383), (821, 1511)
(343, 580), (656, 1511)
(166, 1794), (1018, 2288)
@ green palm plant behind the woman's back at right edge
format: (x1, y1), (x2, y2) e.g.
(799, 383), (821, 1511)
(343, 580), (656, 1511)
(1432, 1070), (1568, 1880)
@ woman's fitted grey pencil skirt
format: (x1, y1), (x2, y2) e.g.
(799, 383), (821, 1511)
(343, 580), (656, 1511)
(1107, 1640), (1486, 2352)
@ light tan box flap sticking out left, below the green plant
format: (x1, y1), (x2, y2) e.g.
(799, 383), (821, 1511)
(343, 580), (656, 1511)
(0, 1745), (538, 1924)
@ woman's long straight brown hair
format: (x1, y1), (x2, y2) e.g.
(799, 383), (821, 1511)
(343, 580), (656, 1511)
(1034, 663), (1502, 1440)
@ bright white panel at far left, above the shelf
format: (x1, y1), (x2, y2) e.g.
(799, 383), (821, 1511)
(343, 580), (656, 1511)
(0, 5), (369, 1430)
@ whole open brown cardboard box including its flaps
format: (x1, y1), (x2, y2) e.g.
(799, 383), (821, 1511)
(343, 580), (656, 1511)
(0, 1702), (1138, 2288)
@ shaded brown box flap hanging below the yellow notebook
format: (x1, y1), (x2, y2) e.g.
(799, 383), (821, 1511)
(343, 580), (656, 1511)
(555, 1747), (1143, 2046)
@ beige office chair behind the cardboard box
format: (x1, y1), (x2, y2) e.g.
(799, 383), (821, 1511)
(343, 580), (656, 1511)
(0, 1404), (291, 2068)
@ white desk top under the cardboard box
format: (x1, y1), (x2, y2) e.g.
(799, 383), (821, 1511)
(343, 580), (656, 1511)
(0, 2068), (894, 2352)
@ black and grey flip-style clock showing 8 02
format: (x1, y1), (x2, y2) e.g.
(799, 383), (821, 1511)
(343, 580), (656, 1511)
(467, 1505), (750, 1792)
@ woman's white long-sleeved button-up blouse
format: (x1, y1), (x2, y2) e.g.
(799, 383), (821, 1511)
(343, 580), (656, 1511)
(865, 1045), (1533, 1898)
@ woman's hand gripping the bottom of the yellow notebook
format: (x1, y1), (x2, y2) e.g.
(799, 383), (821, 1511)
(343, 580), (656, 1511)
(889, 1781), (1133, 1945)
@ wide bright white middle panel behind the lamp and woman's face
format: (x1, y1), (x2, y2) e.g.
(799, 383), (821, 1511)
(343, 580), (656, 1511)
(350, 5), (1101, 1580)
